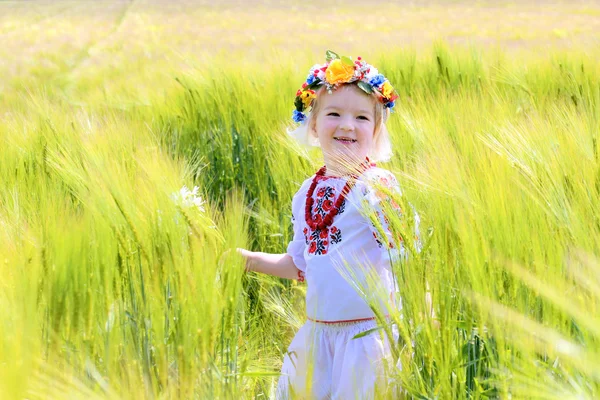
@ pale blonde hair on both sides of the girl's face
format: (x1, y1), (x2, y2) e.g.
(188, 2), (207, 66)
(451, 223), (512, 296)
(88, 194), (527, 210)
(287, 87), (392, 162)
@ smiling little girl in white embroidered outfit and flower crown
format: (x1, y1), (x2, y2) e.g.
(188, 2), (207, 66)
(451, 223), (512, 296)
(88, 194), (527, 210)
(240, 51), (418, 399)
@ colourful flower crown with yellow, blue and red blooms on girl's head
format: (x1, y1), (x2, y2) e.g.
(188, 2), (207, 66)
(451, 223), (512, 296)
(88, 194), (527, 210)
(292, 50), (398, 122)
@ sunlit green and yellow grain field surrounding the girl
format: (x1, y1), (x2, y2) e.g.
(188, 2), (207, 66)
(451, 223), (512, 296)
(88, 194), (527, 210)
(0, 0), (600, 399)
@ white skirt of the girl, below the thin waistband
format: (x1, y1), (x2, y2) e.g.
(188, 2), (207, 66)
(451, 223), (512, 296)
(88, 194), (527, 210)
(276, 320), (391, 400)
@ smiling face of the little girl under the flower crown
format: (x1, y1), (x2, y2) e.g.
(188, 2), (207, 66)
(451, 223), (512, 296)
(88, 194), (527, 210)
(311, 85), (375, 175)
